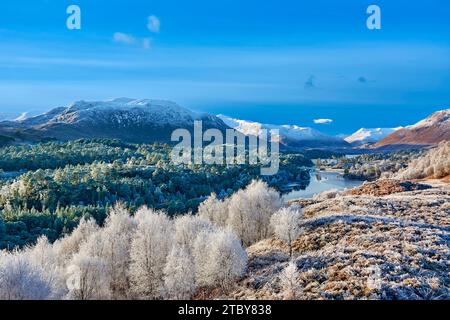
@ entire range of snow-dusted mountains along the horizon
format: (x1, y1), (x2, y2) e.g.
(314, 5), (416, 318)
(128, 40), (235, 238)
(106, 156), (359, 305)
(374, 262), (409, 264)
(0, 98), (450, 152)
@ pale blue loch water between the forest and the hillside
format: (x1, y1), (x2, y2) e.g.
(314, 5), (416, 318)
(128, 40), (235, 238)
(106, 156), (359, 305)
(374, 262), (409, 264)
(283, 170), (363, 201)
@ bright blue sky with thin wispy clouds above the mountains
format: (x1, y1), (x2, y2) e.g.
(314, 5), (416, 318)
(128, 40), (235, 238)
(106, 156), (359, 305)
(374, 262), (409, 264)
(0, 0), (450, 134)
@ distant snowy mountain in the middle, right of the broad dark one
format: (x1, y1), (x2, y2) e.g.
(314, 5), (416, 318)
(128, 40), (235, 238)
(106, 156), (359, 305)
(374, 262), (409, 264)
(217, 115), (349, 148)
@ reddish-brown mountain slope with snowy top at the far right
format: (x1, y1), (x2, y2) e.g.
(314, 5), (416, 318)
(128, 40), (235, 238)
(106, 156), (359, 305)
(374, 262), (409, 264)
(375, 109), (450, 147)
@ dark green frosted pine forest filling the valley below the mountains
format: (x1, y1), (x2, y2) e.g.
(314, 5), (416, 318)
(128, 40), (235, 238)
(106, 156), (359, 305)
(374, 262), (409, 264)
(0, 139), (312, 250)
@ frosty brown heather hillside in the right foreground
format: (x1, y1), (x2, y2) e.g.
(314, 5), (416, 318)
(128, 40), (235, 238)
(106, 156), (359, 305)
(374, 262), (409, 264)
(230, 186), (450, 299)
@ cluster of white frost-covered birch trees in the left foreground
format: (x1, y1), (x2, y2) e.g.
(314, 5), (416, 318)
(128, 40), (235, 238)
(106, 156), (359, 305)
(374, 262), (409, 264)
(0, 198), (253, 300)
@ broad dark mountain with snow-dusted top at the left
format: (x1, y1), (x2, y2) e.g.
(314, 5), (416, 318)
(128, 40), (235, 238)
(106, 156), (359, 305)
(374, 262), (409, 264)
(0, 98), (228, 143)
